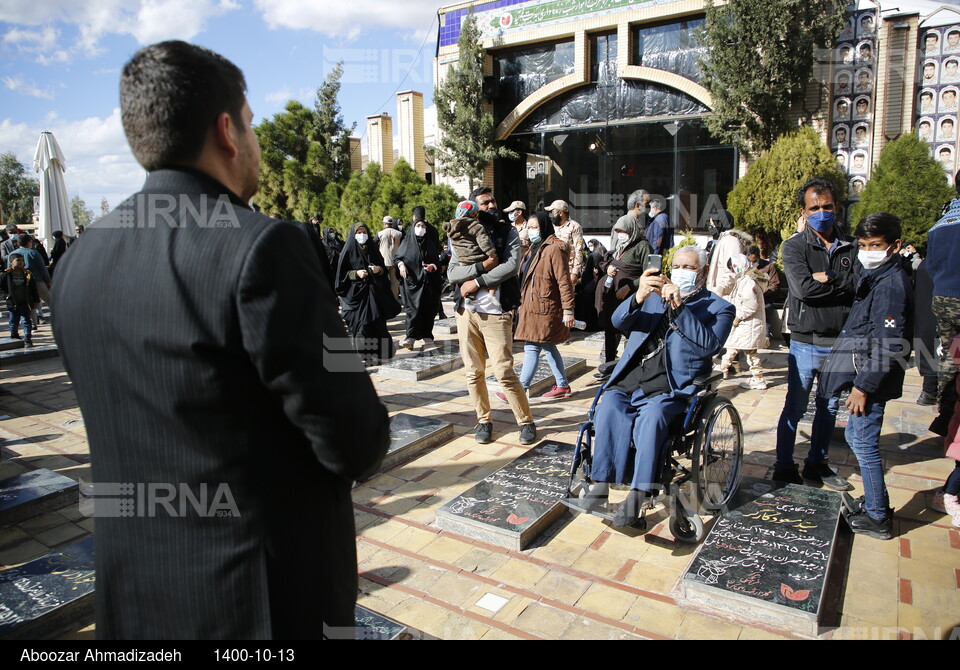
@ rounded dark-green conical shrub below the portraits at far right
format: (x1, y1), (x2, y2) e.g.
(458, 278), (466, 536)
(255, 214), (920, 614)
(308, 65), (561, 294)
(850, 132), (956, 250)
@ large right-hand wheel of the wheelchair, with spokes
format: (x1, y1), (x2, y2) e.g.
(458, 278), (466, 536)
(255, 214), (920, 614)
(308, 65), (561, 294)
(691, 396), (743, 512)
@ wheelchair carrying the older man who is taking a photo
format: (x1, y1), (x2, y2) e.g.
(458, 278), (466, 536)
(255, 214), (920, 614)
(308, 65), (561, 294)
(561, 362), (743, 543)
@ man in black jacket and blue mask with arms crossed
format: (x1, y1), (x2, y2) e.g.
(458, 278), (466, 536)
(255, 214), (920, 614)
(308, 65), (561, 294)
(773, 179), (857, 491)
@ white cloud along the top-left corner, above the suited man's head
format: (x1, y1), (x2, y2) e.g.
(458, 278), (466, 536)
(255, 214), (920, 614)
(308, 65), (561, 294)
(0, 0), (239, 64)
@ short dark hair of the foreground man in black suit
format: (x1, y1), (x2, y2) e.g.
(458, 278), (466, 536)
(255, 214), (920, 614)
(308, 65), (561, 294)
(120, 41), (247, 172)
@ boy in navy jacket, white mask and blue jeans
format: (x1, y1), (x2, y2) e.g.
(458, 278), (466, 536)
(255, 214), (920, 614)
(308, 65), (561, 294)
(819, 214), (913, 540)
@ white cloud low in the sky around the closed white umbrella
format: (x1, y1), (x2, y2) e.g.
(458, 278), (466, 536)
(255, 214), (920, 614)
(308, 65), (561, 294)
(0, 108), (145, 212)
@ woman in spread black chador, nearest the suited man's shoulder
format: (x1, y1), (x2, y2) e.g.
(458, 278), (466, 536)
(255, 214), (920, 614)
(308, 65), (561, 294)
(337, 223), (400, 365)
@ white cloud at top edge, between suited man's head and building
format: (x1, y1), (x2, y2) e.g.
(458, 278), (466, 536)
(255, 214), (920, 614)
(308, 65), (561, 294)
(254, 0), (440, 40)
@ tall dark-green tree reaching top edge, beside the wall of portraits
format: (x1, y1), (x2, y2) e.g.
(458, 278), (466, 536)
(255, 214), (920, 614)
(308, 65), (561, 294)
(698, 0), (846, 155)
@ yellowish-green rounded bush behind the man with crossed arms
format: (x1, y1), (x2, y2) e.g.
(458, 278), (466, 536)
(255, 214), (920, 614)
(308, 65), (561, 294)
(727, 127), (847, 245)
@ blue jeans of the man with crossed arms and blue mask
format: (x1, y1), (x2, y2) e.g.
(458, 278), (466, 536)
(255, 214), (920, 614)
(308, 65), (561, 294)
(775, 338), (840, 469)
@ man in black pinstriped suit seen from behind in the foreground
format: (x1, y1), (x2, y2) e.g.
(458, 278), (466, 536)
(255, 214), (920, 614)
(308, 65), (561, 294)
(54, 42), (389, 639)
